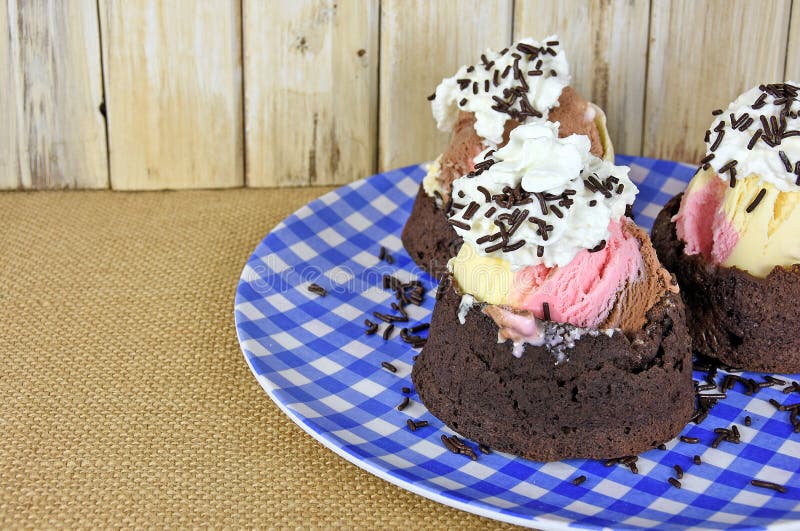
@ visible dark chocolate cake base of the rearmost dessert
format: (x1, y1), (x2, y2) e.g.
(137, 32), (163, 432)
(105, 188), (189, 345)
(401, 185), (464, 278)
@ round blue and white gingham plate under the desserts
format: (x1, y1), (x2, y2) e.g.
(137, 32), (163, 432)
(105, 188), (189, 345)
(235, 156), (800, 530)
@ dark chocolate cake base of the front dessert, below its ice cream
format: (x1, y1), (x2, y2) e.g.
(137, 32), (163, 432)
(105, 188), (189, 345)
(411, 278), (695, 461)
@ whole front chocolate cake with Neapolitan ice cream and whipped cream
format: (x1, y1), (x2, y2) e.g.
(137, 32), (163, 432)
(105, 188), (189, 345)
(412, 121), (694, 461)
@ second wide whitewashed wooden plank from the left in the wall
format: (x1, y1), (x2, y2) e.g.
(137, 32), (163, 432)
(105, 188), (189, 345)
(100, 0), (244, 190)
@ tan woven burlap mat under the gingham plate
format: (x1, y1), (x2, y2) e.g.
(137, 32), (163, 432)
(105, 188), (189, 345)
(0, 188), (520, 529)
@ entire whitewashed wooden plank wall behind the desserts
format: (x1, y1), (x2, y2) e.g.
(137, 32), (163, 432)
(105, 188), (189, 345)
(0, 0), (800, 190)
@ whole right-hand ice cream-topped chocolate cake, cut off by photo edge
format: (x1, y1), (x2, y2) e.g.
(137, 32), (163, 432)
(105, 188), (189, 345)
(652, 82), (800, 373)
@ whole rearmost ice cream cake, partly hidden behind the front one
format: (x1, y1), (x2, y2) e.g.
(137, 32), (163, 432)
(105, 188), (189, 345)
(402, 36), (614, 278)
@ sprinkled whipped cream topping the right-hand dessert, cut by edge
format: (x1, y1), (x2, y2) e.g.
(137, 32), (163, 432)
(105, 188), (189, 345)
(701, 81), (800, 192)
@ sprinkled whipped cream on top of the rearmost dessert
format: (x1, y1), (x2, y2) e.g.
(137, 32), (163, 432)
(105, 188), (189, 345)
(431, 35), (570, 145)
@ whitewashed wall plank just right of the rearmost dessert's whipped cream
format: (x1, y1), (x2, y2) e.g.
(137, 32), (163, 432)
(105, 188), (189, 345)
(514, 0), (650, 155)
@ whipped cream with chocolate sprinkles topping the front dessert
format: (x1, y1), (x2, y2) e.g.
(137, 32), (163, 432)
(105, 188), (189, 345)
(449, 122), (638, 270)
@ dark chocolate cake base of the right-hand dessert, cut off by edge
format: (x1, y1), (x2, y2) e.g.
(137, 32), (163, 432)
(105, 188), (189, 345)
(652, 194), (800, 373)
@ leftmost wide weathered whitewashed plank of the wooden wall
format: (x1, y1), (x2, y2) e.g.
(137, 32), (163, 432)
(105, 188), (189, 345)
(0, 0), (108, 188)
